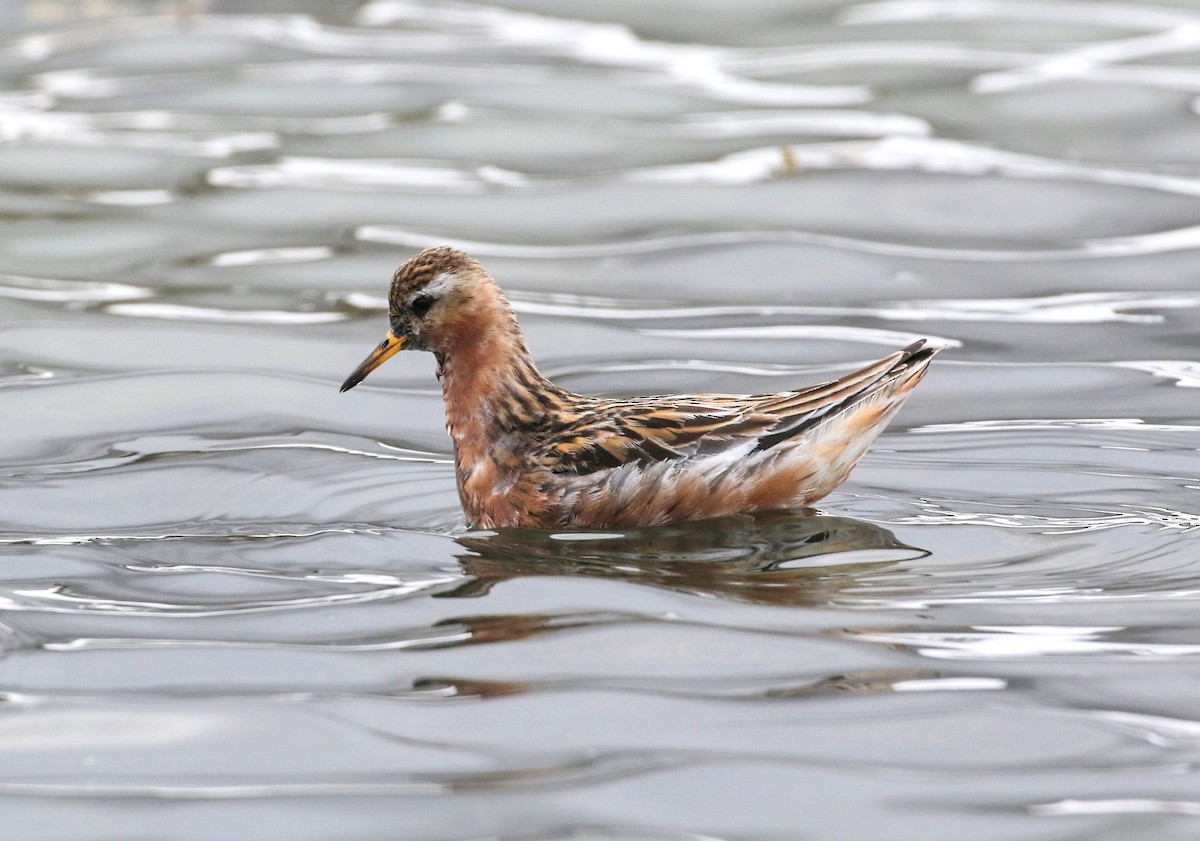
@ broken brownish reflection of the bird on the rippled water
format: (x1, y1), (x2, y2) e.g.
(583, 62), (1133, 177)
(413, 511), (929, 699)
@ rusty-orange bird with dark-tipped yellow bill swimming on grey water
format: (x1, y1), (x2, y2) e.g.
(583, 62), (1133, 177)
(342, 247), (937, 529)
